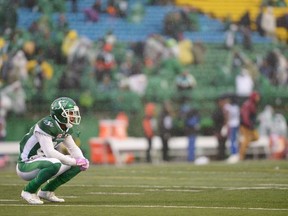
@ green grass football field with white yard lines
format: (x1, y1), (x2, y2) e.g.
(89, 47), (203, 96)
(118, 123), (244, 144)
(0, 160), (288, 216)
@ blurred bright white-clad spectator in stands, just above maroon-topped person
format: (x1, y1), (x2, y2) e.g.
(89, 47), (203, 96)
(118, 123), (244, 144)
(235, 67), (254, 104)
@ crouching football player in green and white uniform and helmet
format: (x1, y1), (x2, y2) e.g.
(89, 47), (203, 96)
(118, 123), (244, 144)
(16, 97), (89, 204)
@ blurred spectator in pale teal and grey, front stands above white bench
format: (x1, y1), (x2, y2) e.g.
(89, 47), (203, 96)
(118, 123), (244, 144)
(175, 70), (197, 104)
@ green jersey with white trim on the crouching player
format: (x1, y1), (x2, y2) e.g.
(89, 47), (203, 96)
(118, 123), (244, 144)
(18, 116), (73, 162)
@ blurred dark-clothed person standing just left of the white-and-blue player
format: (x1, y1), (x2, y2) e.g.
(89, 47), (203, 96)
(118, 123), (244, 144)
(212, 95), (228, 160)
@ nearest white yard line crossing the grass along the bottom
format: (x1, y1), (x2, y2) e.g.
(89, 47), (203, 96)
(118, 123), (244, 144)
(0, 203), (288, 211)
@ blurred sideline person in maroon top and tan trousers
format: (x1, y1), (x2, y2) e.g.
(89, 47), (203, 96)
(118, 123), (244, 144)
(239, 91), (260, 160)
